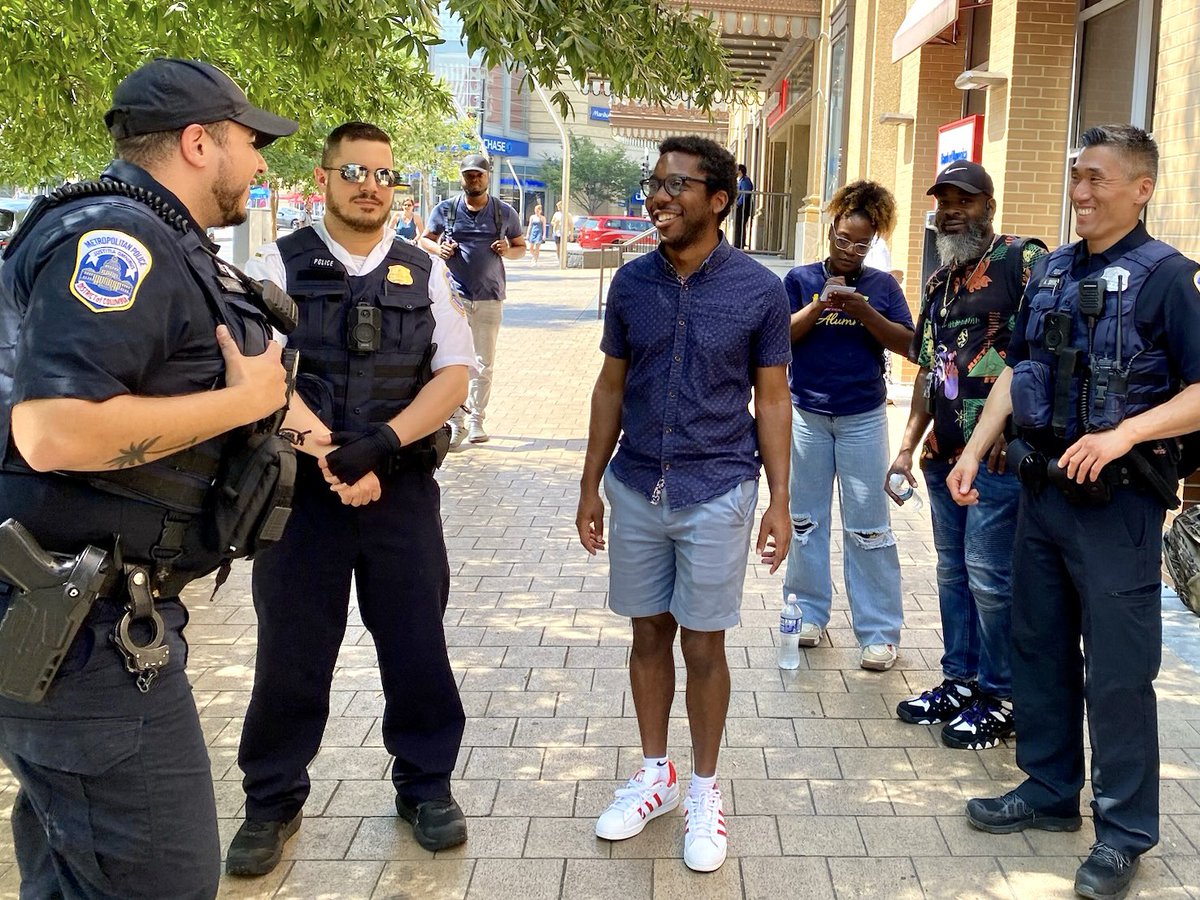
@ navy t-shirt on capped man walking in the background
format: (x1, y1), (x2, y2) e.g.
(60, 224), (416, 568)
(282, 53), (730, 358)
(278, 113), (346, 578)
(425, 194), (524, 300)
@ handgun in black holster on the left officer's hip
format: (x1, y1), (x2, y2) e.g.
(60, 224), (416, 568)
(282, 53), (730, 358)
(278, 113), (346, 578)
(0, 518), (113, 703)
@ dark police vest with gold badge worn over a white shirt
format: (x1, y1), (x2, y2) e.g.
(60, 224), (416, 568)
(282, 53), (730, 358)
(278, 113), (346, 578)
(278, 228), (433, 431)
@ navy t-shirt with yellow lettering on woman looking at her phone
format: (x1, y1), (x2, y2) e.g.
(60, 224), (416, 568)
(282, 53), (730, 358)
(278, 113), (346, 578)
(784, 263), (912, 415)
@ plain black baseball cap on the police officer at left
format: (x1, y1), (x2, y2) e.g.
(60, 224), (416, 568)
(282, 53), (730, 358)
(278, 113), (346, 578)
(104, 56), (300, 149)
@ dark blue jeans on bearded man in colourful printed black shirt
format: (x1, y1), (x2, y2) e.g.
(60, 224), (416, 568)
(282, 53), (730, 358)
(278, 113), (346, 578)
(922, 462), (1021, 700)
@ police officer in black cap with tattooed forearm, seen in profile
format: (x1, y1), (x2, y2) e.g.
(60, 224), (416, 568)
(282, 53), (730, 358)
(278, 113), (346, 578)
(0, 59), (296, 898)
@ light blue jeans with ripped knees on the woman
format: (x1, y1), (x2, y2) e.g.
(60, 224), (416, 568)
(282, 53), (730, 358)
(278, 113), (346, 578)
(784, 404), (904, 647)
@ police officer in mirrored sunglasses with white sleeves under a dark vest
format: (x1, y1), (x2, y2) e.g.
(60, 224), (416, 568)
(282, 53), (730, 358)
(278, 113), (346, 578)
(226, 122), (475, 875)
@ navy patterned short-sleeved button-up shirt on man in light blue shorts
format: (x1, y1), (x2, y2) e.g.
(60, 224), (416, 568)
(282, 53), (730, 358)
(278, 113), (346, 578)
(600, 236), (791, 509)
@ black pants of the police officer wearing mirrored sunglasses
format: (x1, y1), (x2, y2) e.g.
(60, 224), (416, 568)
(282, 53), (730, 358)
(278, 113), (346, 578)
(238, 457), (464, 821)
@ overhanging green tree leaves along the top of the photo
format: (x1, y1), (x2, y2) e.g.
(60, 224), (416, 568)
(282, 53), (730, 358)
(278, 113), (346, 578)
(0, 0), (731, 185)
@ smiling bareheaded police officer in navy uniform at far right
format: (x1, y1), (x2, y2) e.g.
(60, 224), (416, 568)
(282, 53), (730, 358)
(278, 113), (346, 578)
(947, 125), (1200, 898)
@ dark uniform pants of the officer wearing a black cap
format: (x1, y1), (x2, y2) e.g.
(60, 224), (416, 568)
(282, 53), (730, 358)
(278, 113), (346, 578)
(0, 600), (221, 900)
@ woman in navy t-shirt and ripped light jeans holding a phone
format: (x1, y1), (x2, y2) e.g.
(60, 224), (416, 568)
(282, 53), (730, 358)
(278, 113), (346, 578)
(784, 181), (912, 671)
